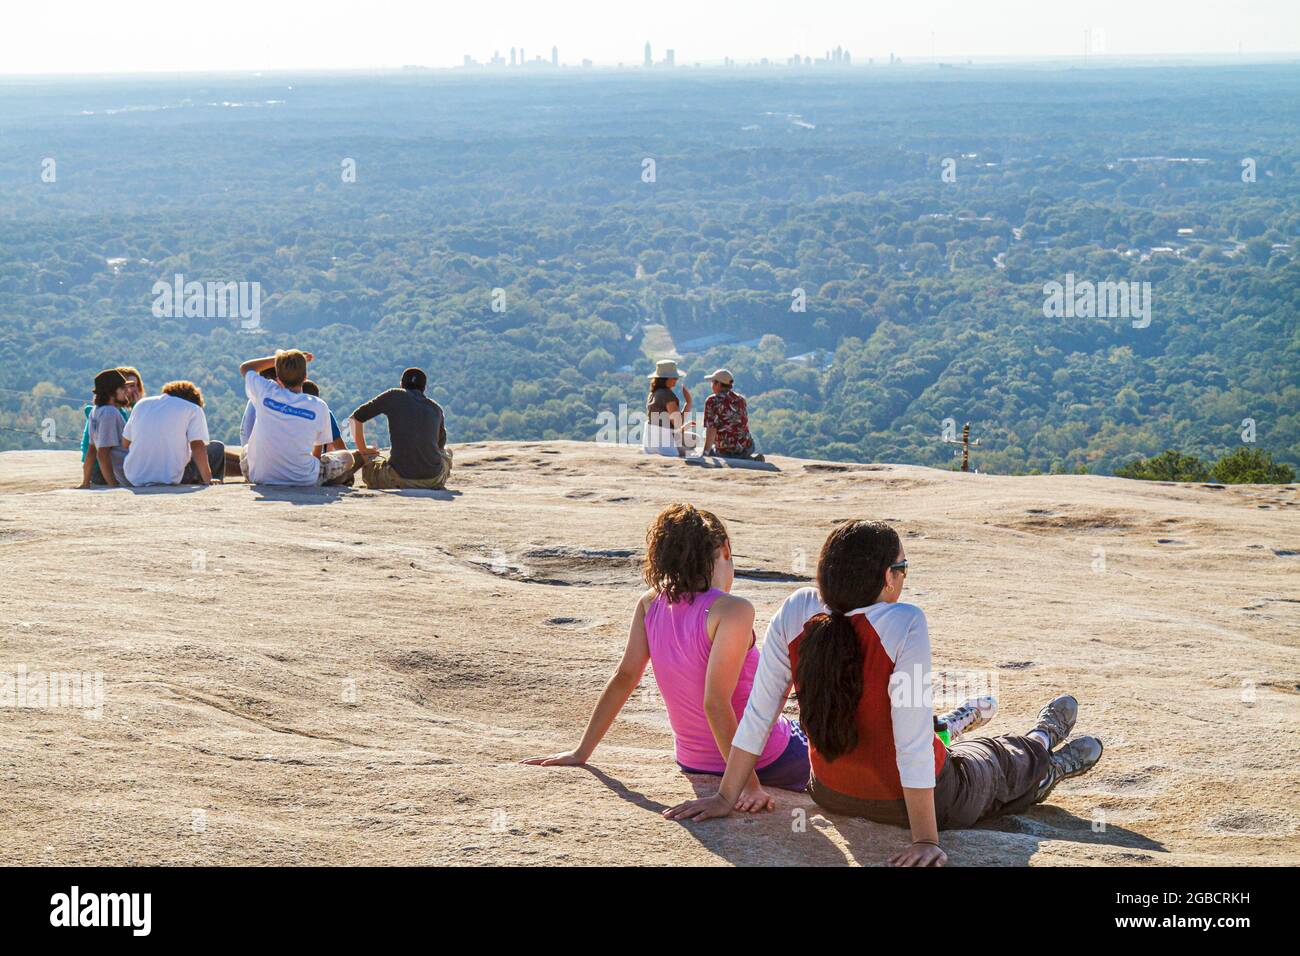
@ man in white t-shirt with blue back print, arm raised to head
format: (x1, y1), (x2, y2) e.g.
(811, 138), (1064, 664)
(239, 349), (363, 486)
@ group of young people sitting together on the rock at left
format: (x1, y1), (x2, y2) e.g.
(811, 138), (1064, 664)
(81, 349), (452, 489)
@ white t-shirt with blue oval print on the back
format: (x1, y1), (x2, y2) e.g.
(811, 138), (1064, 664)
(244, 372), (334, 485)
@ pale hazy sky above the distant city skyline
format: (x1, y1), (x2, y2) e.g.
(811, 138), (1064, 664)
(0, 0), (1300, 73)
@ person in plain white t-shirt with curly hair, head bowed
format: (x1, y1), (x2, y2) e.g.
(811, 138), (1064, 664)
(122, 381), (226, 488)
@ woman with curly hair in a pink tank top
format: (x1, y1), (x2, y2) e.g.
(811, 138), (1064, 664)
(524, 505), (809, 812)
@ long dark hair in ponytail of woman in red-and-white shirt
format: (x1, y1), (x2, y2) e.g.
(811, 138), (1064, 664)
(794, 522), (901, 761)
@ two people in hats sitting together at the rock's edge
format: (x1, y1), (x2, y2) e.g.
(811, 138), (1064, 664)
(642, 359), (763, 462)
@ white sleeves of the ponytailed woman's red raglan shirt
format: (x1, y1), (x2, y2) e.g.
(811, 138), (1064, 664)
(732, 588), (935, 788)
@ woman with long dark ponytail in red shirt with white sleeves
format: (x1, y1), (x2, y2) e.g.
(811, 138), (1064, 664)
(664, 522), (1102, 866)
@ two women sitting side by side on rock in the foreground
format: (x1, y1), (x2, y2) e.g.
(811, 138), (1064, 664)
(523, 505), (1102, 866)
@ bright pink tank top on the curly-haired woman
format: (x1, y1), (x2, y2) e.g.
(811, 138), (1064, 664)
(646, 588), (790, 774)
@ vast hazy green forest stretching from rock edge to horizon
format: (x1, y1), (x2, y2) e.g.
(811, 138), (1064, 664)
(0, 65), (1300, 473)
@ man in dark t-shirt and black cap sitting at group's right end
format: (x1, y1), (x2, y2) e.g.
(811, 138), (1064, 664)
(351, 368), (451, 488)
